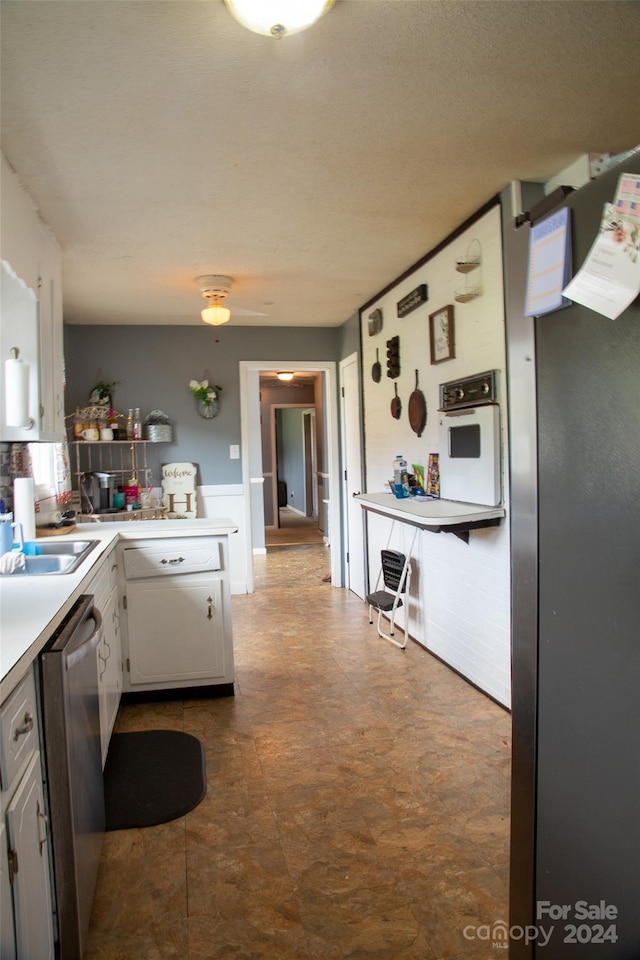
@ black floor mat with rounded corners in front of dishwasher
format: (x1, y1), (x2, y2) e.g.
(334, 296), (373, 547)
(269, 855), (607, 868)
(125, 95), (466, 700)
(104, 730), (207, 830)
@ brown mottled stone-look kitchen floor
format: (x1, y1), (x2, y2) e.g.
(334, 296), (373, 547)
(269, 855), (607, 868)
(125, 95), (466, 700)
(85, 545), (510, 960)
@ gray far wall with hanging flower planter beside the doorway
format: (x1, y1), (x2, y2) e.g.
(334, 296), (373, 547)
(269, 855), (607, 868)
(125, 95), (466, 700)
(65, 324), (342, 484)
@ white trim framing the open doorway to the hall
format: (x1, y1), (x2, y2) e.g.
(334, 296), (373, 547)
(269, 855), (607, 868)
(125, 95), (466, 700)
(239, 360), (344, 593)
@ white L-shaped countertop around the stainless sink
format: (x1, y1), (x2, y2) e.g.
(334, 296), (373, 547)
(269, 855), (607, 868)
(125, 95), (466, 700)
(0, 518), (238, 702)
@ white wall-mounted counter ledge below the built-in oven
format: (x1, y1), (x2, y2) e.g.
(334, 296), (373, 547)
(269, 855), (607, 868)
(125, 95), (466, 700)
(355, 493), (506, 532)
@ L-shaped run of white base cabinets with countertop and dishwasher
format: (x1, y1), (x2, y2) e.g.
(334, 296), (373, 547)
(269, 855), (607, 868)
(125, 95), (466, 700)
(0, 519), (237, 960)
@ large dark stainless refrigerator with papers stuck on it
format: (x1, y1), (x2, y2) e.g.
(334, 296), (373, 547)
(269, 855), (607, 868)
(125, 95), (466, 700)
(503, 150), (640, 960)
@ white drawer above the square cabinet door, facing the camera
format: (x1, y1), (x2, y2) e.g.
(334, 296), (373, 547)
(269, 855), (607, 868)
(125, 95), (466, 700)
(122, 537), (222, 580)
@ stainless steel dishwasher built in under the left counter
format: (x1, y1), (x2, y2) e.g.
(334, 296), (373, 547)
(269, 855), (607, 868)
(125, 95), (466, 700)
(40, 595), (105, 960)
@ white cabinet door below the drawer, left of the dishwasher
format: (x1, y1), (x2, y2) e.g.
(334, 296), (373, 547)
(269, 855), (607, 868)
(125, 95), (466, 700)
(7, 752), (54, 960)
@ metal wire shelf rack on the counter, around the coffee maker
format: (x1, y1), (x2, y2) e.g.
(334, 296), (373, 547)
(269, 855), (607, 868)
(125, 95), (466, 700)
(70, 440), (166, 523)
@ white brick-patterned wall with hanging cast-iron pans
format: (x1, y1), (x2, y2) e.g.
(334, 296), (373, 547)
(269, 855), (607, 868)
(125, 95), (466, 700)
(362, 206), (511, 705)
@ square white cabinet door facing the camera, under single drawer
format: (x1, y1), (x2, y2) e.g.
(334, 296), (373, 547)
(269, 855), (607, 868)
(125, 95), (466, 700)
(127, 574), (225, 687)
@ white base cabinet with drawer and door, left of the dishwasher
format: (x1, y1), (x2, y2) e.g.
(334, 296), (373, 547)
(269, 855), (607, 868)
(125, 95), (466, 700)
(0, 672), (54, 960)
